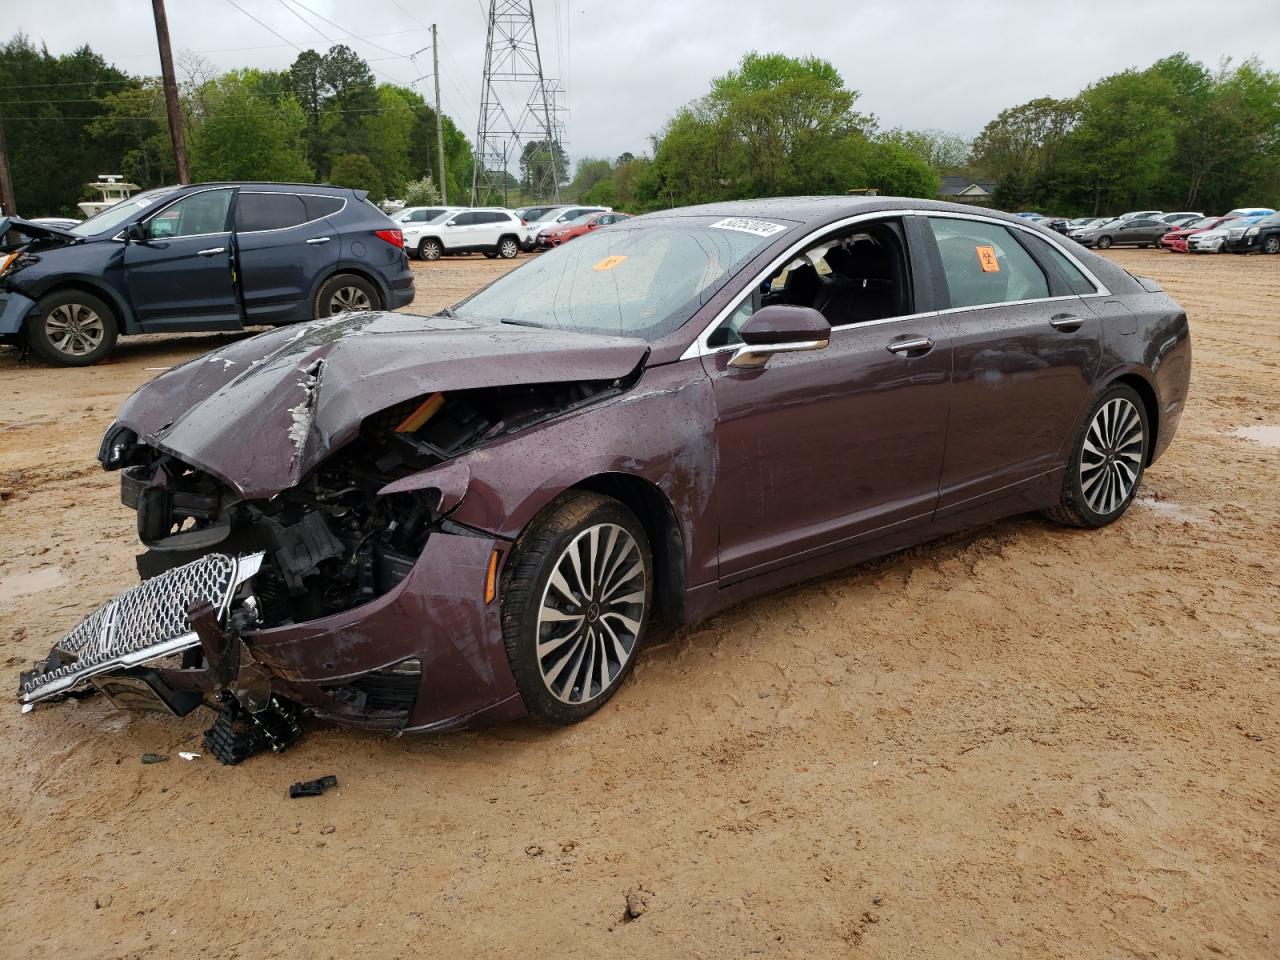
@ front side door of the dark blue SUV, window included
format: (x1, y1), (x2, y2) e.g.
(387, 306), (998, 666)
(123, 187), (241, 332)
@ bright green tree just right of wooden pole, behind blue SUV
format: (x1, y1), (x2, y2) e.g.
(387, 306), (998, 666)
(191, 70), (315, 182)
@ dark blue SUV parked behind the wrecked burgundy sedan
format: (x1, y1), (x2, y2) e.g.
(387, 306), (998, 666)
(0, 183), (413, 366)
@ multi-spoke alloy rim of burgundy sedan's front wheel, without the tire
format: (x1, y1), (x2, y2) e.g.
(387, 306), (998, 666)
(536, 524), (646, 704)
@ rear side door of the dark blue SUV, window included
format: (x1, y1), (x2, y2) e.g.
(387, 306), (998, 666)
(233, 189), (344, 324)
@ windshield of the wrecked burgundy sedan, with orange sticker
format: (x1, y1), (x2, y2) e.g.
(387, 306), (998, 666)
(454, 216), (791, 340)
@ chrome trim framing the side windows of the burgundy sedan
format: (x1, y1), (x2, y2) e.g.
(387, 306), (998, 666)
(680, 210), (1111, 360)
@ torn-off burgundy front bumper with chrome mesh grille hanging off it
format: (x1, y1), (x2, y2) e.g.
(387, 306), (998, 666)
(19, 531), (525, 731)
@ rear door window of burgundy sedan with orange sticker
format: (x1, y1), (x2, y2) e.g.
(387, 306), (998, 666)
(927, 216), (1048, 307)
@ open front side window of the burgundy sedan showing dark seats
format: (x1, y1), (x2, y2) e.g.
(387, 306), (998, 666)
(708, 220), (911, 347)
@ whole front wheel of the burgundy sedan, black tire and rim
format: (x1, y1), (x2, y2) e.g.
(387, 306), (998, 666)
(502, 492), (653, 724)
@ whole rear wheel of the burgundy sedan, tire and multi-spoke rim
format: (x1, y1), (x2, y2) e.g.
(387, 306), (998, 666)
(1044, 384), (1151, 529)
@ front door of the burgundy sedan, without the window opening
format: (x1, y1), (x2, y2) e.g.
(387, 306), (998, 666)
(703, 215), (951, 584)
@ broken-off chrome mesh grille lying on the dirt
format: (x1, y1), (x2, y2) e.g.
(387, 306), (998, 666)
(18, 553), (262, 704)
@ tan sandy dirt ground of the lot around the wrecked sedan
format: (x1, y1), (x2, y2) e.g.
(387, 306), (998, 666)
(0, 251), (1280, 960)
